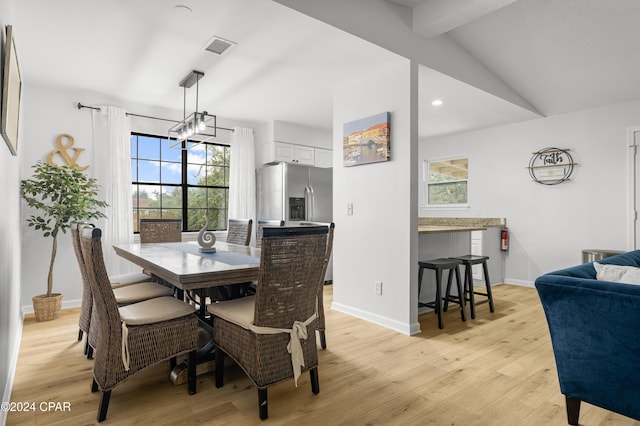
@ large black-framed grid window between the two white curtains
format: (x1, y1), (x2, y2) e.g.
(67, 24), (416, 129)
(131, 133), (231, 232)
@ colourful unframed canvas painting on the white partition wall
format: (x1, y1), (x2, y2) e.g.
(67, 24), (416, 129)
(342, 112), (391, 167)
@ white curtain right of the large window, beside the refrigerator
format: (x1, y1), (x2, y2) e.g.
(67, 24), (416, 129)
(229, 127), (256, 236)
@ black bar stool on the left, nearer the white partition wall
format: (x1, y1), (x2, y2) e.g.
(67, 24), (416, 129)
(418, 259), (467, 328)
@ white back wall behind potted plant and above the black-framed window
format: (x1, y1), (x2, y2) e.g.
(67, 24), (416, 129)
(19, 85), (262, 312)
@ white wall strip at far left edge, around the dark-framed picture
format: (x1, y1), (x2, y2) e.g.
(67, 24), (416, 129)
(0, 0), (24, 424)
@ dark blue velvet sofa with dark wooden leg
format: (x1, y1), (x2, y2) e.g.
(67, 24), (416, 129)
(535, 250), (640, 425)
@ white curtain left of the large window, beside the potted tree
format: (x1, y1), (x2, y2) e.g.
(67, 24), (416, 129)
(91, 106), (138, 275)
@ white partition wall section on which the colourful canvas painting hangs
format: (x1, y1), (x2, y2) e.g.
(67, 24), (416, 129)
(332, 57), (419, 334)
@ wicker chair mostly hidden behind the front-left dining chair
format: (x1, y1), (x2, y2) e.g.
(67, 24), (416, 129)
(71, 223), (173, 359)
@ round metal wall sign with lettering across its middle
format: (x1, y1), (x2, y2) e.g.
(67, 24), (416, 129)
(527, 148), (576, 185)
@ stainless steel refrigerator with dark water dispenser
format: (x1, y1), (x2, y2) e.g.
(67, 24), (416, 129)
(256, 163), (333, 281)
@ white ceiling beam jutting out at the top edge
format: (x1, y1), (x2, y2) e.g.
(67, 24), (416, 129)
(413, 0), (517, 38)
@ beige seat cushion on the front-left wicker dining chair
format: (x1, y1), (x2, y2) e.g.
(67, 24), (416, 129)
(118, 297), (195, 325)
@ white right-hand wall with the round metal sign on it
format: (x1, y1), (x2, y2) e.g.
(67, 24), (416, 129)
(419, 101), (640, 286)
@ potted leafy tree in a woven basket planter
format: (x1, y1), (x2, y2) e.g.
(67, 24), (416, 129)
(20, 162), (107, 321)
